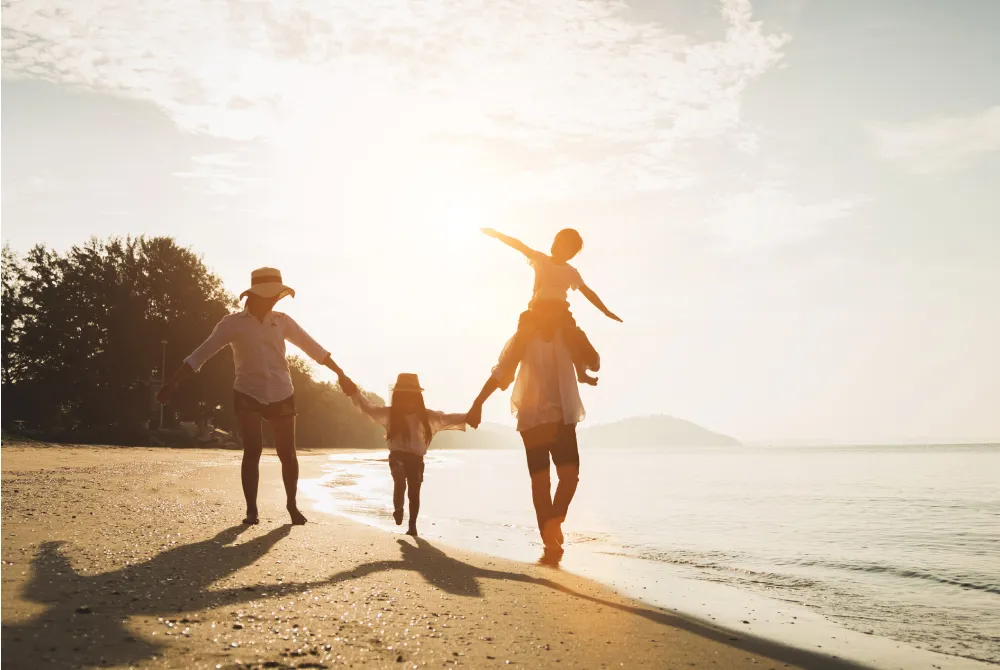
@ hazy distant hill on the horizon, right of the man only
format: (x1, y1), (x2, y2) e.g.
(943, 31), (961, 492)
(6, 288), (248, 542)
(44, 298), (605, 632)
(579, 414), (741, 447)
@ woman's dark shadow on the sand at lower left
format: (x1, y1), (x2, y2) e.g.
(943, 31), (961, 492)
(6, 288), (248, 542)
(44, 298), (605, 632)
(2, 525), (332, 668)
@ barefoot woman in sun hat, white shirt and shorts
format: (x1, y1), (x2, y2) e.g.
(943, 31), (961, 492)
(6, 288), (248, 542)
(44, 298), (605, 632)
(157, 268), (355, 525)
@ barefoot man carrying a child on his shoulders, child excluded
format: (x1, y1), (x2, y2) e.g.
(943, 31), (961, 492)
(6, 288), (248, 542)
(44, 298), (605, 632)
(467, 315), (596, 563)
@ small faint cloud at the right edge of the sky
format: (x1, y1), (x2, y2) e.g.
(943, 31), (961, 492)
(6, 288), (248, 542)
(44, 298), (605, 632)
(873, 105), (1000, 174)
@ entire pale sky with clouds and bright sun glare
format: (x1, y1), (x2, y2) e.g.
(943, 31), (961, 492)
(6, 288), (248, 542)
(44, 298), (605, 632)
(0, 0), (1000, 442)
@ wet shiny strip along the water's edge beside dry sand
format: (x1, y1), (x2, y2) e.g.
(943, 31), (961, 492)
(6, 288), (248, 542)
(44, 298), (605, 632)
(303, 450), (991, 670)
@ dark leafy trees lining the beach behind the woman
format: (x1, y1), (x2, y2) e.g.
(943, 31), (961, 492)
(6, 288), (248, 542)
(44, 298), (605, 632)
(0, 236), (384, 448)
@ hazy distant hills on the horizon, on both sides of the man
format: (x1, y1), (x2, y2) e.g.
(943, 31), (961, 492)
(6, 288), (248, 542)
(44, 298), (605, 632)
(432, 415), (740, 449)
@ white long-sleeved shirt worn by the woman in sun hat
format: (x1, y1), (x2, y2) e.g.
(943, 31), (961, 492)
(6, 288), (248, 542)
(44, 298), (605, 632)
(184, 309), (330, 405)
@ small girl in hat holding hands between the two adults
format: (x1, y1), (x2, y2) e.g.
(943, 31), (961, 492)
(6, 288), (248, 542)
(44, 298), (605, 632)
(344, 372), (466, 536)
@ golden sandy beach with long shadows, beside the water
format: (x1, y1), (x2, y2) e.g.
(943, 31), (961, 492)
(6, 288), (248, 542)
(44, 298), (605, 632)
(2, 444), (857, 669)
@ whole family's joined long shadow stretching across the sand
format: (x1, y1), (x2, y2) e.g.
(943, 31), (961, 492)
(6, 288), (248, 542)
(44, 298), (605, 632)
(2, 526), (860, 670)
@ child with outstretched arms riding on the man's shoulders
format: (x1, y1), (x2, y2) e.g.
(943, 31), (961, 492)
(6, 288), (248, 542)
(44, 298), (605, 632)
(483, 228), (621, 388)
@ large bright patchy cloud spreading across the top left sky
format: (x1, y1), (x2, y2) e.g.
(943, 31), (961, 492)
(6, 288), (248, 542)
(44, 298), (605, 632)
(3, 0), (788, 196)
